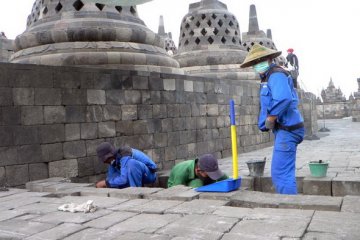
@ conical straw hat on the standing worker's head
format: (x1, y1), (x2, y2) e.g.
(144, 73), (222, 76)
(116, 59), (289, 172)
(240, 43), (281, 68)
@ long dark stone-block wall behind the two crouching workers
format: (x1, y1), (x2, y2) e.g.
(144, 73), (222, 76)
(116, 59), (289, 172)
(0, 63), (271, 186)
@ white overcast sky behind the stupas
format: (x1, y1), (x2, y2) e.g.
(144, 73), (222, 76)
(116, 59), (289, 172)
(0, 0), (360, 98)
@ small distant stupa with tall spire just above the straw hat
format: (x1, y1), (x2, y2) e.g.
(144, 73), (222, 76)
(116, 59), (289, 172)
(242, 5), (277, 51)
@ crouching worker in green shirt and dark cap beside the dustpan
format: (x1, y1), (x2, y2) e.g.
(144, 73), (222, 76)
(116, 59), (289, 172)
(168, 154), (229, 188)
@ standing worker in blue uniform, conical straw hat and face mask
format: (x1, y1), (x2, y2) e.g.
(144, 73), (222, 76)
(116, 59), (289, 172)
(241, 44), (305, 194)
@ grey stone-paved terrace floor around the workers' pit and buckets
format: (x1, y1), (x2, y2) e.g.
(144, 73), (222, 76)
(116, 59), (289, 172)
(0, 119), (360, 240)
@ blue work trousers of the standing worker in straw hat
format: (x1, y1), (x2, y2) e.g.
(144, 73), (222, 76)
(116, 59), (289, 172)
(271, 128), (305, 194)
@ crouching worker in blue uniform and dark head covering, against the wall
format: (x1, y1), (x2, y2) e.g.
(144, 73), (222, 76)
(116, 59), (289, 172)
(96, 142), (157, 188)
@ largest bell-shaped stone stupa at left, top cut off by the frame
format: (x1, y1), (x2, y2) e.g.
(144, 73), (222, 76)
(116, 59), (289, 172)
(11, 0), (182, 73)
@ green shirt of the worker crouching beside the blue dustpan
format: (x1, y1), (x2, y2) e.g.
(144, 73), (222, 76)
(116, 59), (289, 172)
(168, 160), (229, 188)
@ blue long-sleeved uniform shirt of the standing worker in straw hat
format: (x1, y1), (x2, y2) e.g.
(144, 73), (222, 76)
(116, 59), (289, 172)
(258, 64), (304, 131)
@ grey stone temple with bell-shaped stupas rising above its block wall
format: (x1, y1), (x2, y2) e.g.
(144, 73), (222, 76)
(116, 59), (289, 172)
(0, 0), (317, 186)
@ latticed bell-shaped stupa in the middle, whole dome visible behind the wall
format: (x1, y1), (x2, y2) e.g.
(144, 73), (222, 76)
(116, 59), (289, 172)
(174, 0), (255, 79)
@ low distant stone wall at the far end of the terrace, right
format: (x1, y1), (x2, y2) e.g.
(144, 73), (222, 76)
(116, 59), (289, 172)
(316, 102), (352, 119)
